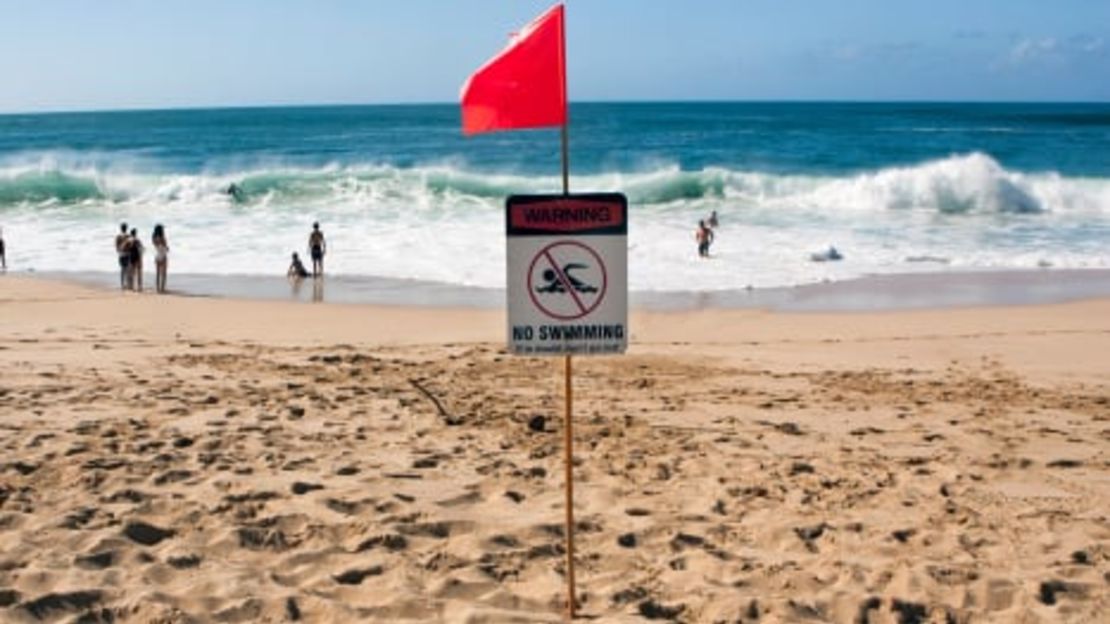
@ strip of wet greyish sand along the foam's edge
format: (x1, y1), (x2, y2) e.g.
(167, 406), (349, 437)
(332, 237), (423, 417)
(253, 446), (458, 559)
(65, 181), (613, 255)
(23, 263), (1110, 312)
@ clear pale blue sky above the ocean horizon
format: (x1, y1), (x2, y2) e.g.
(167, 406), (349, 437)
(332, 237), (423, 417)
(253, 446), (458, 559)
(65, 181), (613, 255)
(0, 0), (1110, 112)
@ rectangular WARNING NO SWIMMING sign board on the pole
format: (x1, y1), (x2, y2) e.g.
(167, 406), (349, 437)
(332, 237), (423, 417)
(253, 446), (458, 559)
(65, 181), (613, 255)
(505, 193), (628, 355)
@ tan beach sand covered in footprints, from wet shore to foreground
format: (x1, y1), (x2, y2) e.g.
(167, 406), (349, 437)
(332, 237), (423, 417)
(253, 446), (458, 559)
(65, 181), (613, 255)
(0, 275), (1110, 623)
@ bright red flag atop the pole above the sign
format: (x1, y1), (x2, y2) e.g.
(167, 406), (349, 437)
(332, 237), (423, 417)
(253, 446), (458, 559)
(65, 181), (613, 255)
(462, 4), (566, 134)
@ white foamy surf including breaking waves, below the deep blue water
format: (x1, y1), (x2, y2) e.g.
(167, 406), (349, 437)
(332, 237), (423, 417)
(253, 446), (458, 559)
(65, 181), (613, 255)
(0, 153), (1110, 291)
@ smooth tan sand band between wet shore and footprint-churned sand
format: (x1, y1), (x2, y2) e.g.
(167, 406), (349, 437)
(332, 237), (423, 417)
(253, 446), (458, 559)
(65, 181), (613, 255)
(0, 275), (1110, 359)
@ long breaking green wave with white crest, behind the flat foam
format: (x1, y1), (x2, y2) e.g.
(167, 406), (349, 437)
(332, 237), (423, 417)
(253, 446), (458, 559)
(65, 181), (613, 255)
(0, 152), (1110, 215)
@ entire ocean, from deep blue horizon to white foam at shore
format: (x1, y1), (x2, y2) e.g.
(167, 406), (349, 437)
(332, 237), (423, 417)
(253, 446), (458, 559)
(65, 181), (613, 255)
(0, 102), (1110, 293)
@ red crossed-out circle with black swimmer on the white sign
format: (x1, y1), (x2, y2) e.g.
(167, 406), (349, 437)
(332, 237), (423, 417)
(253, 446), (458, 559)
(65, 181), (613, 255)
(527, 240), (608, 321)
